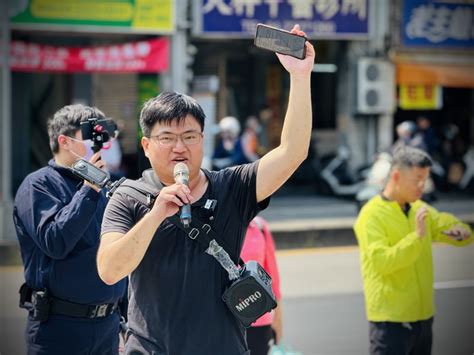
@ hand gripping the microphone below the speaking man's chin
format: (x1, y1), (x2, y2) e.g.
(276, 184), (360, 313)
(150, 183), (194, 218)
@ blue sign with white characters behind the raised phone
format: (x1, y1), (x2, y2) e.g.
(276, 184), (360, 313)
(193, 0), (369, 39)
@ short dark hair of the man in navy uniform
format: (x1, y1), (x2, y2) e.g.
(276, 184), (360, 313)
(48, 104), (106, 154)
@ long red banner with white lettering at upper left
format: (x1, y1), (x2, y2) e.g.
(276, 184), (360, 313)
(10, 38), (169, 73)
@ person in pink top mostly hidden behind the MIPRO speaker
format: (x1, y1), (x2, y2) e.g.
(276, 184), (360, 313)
(240, 216), (282, 355)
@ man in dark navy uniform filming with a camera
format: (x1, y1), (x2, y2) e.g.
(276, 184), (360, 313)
(13, 105), (125, 355)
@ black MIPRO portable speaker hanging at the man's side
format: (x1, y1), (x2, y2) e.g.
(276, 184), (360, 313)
(222, 260), (277, 327)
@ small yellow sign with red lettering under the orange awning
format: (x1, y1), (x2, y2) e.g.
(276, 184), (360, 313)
(399, 85), (443, 110)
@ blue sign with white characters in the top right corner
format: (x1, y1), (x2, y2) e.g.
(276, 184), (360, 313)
(402, 0), (474, 48)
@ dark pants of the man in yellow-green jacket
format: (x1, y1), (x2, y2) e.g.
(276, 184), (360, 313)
(369, 318), (433, 355)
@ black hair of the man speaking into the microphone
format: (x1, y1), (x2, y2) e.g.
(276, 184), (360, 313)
(140, 92), (206, 137)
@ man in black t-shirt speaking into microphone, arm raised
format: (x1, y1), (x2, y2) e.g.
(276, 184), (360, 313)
(97, 26), (314, 355)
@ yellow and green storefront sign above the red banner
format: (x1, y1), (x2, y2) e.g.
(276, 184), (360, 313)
(11, 0), (175, 33)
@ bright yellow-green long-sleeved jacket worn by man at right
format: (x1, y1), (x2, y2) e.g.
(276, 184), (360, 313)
(354, 196), (473, 322)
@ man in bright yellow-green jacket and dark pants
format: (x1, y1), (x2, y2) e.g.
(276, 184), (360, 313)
(354, 147), (473, 355)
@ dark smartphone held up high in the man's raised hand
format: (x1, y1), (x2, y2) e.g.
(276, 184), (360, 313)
(254, 23), (308, 59)
